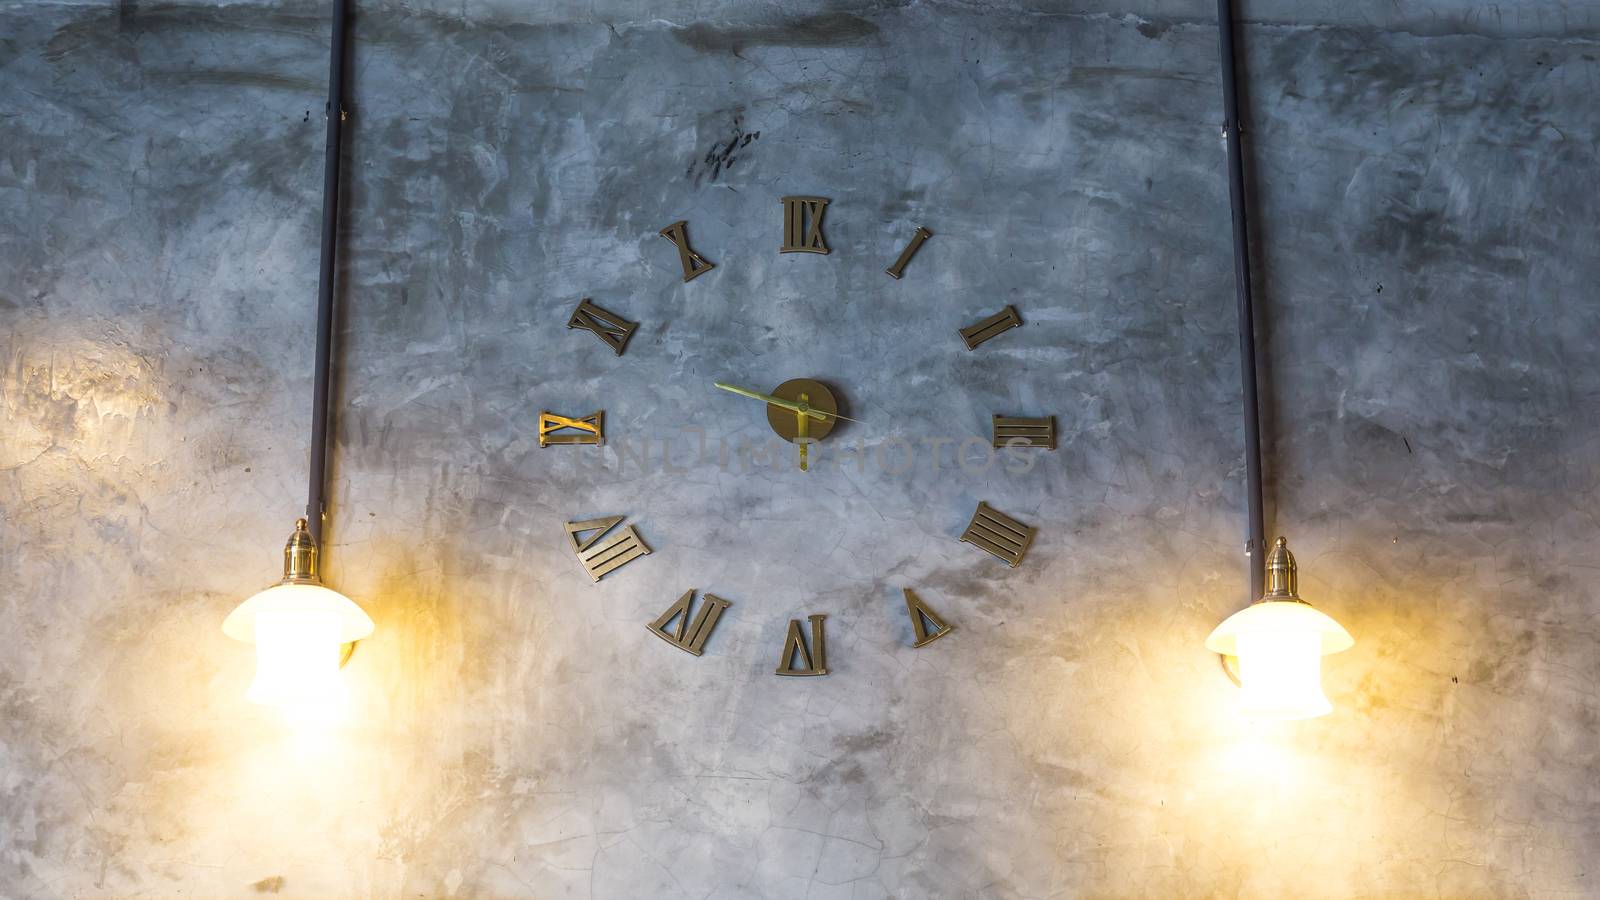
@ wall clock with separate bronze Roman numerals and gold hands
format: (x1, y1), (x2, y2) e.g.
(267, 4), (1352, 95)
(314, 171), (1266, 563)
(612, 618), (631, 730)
(539, 197), (1056, 676)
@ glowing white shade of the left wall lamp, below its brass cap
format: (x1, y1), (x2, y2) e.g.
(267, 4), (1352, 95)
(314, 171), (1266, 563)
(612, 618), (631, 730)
(222, 585), (373, 721)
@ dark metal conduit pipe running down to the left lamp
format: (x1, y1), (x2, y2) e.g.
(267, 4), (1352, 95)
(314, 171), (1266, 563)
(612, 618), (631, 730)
(306, 0), (346, 544)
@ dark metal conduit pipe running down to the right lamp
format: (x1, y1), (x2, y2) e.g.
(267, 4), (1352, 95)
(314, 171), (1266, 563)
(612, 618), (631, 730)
(1216, 0), (1267, 602)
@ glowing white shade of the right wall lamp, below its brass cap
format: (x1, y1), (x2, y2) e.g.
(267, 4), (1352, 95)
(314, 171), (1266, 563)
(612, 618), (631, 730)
(1205, 601), (1355, 719)
